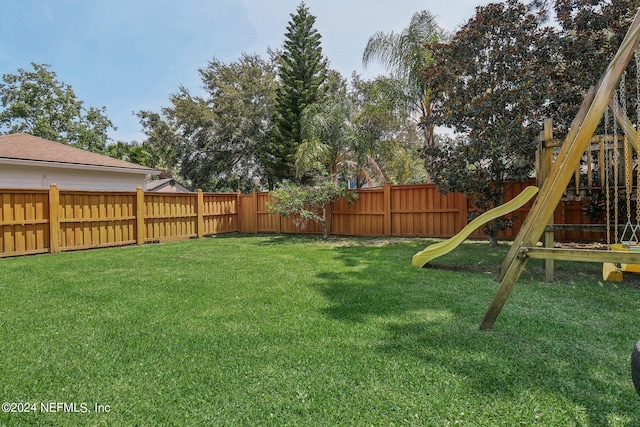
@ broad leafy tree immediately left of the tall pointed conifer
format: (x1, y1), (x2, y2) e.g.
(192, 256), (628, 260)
(138, 54), (275, 191)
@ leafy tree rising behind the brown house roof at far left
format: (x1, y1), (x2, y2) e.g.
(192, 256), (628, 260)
(0, 63), (115, 153)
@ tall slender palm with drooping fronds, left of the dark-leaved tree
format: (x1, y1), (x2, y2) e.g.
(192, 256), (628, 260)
(362, 10), (446, 182)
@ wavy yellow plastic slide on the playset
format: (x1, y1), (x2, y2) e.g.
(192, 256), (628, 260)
(411, 186), (538, 267)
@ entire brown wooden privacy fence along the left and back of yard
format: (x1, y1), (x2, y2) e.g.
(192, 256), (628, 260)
(0, 183), (604, 257)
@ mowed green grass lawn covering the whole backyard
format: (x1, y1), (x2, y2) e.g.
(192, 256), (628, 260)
(0, 236), (640, 427)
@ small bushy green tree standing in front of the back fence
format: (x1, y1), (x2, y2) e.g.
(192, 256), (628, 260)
(267, 179), (358, 239)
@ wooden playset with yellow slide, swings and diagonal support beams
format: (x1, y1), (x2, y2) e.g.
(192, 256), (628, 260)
(412, 9), (640, 330)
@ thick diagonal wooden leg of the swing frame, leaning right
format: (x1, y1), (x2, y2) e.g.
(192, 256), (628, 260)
(480, 9), (640, 330)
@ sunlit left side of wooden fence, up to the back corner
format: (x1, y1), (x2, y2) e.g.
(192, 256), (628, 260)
(0, 184), (238, 257)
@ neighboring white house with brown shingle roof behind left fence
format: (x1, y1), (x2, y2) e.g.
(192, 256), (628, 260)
(0, 133), (160, 191)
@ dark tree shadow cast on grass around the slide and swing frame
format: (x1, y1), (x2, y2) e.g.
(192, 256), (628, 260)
(317, 241), (640, 425)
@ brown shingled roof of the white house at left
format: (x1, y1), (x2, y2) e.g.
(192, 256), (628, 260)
(0, 133), (159, 175)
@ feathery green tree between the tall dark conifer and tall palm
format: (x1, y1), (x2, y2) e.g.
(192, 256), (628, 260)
(296, 75), (421, 187)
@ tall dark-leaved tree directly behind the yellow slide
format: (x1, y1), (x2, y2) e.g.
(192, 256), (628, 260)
(426, 0), (554, 244)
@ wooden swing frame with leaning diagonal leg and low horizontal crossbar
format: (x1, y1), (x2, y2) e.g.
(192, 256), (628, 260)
(480, 9), (640, 330)
